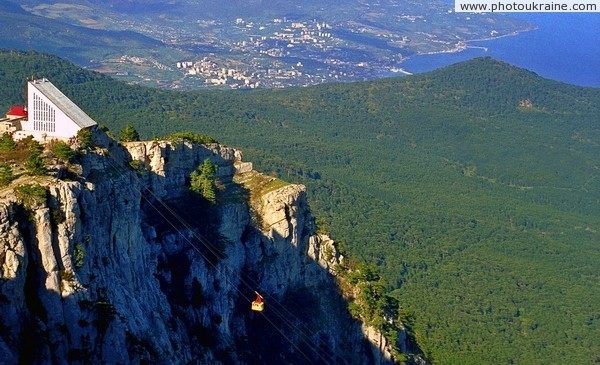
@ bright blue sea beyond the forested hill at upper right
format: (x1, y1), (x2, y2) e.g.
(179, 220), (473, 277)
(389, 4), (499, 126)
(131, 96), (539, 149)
(400, 13), (600, 87)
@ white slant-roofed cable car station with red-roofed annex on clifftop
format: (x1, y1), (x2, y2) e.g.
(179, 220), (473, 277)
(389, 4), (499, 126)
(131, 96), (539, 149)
(0, 79), (97, 142)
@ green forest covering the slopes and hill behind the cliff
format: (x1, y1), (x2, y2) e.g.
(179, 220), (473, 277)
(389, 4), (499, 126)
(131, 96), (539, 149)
(0, 51), (600, 364)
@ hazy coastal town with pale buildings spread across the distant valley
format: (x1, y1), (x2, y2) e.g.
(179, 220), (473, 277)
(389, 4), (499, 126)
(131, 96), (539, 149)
(55, 2), (529, 89)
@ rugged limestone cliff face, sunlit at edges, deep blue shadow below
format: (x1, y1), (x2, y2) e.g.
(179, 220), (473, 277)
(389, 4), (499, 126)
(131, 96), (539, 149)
(0, 141), (398, 364)
